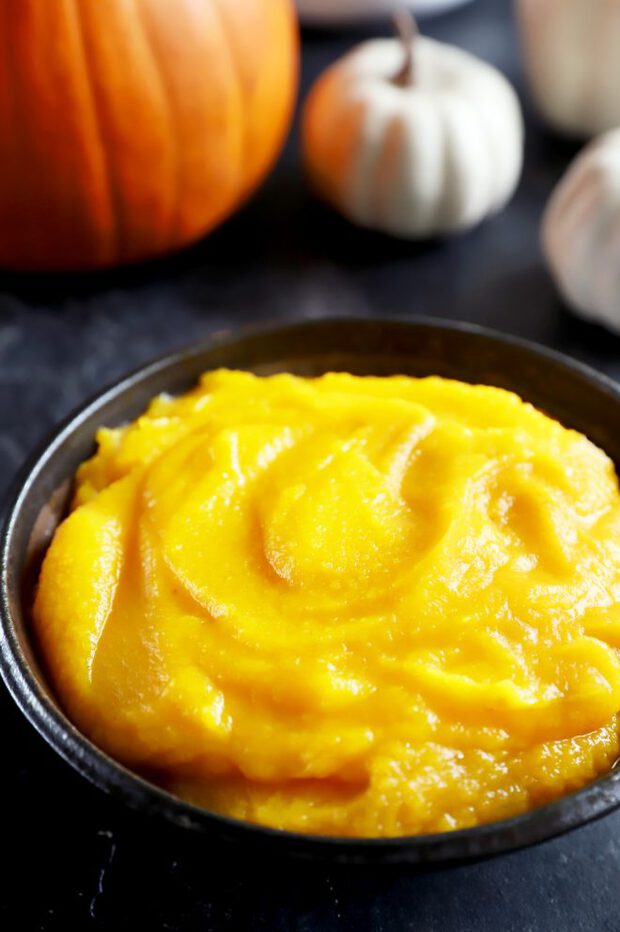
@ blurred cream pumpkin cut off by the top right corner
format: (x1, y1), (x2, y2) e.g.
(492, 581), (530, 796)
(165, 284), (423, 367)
(516, 0), (620, 136)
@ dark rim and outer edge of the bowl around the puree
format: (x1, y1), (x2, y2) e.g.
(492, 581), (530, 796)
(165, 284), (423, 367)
(0, 316), (620, 867)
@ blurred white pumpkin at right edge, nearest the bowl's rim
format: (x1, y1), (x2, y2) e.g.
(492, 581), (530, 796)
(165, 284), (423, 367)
(542, 130), (620, 332)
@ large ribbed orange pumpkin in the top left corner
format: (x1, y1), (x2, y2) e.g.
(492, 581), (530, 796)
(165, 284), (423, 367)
(0, 0), (298, 269)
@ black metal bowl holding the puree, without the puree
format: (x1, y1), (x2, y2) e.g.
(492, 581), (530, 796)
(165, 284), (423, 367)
(0, 318), (620, 866)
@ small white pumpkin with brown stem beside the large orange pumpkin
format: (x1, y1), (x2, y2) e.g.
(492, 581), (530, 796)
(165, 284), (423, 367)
(302, 15), (523, 239)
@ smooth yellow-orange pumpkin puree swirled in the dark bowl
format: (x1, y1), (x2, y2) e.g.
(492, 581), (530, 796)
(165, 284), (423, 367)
(35, 371), (620, 836)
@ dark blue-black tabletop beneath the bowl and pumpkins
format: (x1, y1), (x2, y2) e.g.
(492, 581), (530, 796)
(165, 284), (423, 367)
(0, 0), (620, 932)
